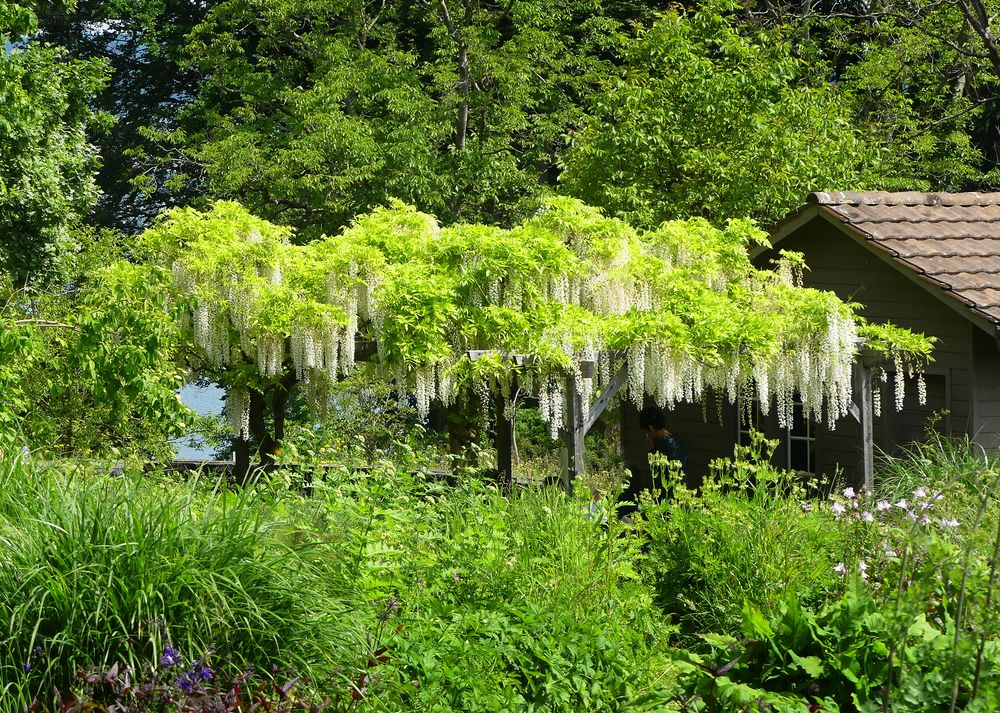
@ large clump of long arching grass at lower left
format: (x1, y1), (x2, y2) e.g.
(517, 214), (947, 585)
(0, 461), (356, 710)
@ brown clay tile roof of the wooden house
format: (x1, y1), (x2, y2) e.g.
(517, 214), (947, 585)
(808, 192), (1000, 325)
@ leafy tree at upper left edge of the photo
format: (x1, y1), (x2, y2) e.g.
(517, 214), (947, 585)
(0, 3), (104, 285)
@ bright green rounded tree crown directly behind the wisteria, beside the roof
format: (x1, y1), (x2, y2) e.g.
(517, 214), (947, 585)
(561, 4), (876, 226)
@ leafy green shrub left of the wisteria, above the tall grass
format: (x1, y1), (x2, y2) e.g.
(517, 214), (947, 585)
(0, 261), (189, 457)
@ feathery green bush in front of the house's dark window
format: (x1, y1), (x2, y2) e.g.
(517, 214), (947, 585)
(639, 442), (859, 635)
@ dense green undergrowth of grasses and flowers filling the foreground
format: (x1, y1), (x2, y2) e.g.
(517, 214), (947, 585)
(0, 434), (1000, 711)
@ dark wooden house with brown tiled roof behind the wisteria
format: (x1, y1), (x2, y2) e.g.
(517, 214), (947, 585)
(622, 192), (1000, 482)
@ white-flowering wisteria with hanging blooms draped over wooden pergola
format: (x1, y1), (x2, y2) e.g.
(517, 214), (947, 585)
(142, 198), (929, 472)
